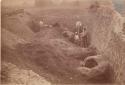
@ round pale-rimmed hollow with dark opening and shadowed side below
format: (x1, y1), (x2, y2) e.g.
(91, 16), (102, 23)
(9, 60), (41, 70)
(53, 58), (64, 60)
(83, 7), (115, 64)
(77, 55), (113, 83)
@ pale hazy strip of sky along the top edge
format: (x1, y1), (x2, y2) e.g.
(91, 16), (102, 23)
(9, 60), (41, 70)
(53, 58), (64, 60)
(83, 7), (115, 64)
(0, 0), (125, 6)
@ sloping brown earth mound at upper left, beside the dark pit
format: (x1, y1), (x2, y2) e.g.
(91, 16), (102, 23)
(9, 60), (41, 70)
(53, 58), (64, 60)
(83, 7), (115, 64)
(2, 10), (34, 41)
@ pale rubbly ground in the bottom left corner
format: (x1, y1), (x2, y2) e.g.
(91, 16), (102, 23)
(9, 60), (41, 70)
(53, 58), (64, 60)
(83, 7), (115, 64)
(1, 62), (51, 85)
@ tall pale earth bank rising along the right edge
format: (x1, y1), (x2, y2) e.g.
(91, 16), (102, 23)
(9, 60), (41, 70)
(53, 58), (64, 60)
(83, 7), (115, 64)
(89, 3), (125, 83)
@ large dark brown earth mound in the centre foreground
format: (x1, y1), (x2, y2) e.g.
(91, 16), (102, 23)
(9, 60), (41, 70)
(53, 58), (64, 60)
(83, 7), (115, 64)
(14, 39), (98, 83)
